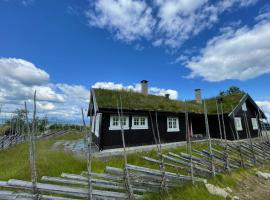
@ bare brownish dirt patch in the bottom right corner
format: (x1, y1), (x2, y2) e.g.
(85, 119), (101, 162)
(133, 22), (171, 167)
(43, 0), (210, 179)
(234, 173), (270, 200)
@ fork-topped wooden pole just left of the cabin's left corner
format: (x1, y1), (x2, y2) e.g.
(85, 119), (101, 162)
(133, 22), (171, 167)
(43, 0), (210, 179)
(81, 108), (93, 200)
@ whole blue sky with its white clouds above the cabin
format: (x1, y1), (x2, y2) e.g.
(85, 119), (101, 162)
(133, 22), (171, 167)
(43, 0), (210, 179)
(0, 0), (270, 117)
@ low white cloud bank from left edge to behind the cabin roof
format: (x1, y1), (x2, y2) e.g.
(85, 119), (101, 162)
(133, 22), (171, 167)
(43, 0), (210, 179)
(0, 58), (177, 123)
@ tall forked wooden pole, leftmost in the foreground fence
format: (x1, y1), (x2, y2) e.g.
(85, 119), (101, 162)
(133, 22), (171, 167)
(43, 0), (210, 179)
(24, 91), (39, 200)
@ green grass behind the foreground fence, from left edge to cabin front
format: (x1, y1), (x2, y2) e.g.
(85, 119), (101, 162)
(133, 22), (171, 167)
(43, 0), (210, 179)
(0, 133), (213, 180)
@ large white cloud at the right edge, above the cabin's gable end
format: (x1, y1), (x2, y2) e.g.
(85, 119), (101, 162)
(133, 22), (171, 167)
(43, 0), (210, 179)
(186, 21), (270, 82)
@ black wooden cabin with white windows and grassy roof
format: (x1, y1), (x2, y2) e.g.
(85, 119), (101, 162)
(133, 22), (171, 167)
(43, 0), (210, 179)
(88, 82), (265, 150)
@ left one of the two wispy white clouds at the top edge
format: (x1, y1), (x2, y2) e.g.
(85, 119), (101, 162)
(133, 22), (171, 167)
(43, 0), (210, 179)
(86, 0), (155, 41)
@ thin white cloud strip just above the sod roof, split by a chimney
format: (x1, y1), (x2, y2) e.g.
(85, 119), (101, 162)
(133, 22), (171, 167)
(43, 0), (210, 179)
(92, 82), (178, 99)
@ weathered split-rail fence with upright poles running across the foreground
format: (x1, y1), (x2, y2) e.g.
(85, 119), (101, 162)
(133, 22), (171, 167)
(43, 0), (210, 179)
(0, 92), (270, 200)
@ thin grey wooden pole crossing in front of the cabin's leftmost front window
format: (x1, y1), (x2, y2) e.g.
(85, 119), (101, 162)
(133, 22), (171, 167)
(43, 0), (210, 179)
(117, 96), (134, 199)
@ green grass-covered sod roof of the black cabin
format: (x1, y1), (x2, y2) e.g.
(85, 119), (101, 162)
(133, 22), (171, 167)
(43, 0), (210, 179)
(94, 89), (244, 113)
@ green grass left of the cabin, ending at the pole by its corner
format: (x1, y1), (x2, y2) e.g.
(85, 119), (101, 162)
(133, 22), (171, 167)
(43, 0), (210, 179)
(0, 133), (86, 180)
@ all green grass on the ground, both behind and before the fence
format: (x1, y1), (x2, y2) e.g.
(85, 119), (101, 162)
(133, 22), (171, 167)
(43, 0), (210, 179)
(0, 133), (270, 200)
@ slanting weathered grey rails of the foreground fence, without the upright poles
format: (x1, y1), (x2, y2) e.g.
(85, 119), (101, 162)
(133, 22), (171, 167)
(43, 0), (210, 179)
(0, 141), (270, 200)
